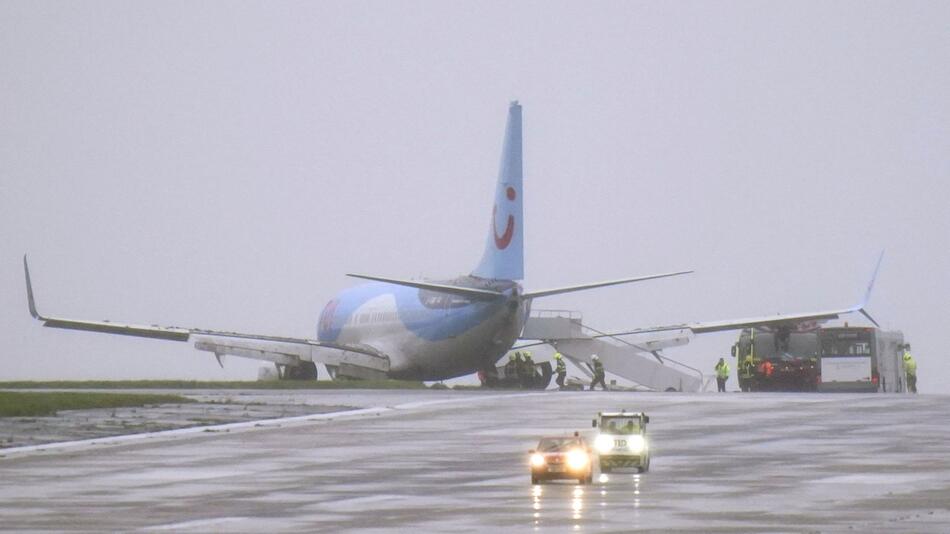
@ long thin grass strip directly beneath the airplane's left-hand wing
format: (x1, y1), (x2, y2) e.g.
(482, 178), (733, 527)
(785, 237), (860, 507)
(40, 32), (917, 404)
(0, 380), (426, 389)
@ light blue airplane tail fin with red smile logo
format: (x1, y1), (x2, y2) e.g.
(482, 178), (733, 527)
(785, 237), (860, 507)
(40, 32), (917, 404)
(472, 101), (524, 280)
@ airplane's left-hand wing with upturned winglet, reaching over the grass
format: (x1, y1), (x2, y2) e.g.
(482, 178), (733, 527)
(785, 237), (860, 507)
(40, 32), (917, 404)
(23, 256), (389, 372)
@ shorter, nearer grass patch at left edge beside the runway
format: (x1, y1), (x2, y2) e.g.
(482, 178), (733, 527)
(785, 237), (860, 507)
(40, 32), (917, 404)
(0, 391), (194, 417)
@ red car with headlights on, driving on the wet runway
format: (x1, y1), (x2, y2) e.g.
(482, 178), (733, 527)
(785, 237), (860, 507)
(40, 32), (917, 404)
(528, 434), (593, 484)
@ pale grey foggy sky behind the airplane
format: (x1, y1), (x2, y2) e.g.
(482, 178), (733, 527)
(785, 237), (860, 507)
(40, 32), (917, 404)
(0, 1), (950, 393)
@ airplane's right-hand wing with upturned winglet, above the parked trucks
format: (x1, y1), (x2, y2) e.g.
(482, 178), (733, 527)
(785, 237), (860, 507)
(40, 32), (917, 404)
(594, 251), (884, 337)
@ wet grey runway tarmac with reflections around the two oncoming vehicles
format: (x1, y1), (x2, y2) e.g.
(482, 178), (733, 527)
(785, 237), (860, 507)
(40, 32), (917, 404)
(0, 391), (950, 532)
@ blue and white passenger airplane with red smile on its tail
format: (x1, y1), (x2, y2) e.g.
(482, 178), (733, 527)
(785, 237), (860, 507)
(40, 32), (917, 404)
(23, 101), (880, 381)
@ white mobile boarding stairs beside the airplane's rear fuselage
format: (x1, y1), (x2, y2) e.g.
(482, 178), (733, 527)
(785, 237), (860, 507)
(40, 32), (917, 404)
(521, 310), (703, 391)
